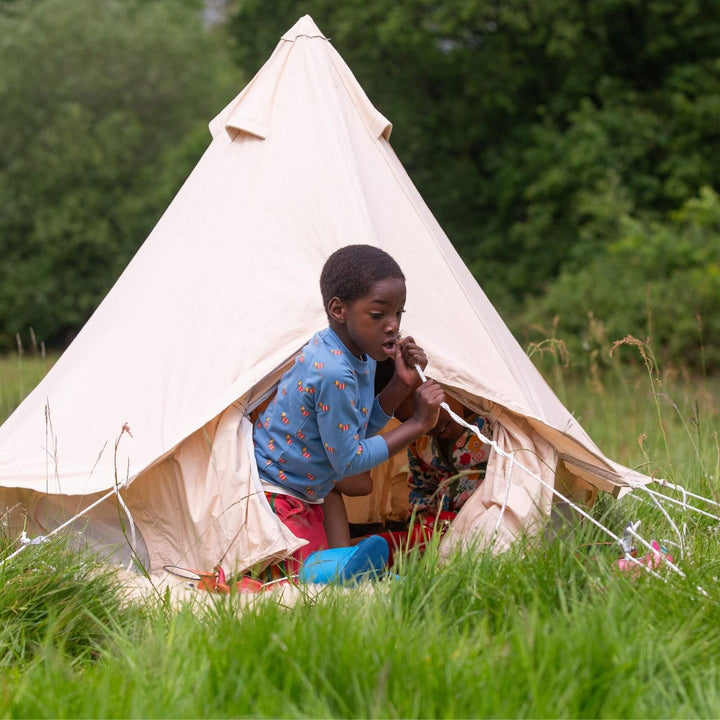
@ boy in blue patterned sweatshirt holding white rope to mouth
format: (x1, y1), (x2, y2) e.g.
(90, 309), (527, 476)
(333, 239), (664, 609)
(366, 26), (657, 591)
(254, 245), (445, 572)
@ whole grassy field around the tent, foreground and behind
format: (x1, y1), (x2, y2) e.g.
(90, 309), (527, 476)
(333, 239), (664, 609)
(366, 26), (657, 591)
(0, 348), (720, 718)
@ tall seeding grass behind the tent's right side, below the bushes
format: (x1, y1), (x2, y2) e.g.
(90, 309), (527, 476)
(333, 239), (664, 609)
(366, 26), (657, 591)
(529, 326), (720, 494)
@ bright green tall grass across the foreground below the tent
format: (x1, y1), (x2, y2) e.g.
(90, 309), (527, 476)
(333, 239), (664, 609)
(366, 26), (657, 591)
(0, 531), (720, 718)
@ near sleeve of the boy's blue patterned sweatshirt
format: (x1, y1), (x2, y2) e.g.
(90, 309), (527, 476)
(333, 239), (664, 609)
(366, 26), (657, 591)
(316, 370), (388, 478)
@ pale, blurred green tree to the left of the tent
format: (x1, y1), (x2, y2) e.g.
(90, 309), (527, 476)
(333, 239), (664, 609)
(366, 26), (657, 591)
(0, 0), (236, 347)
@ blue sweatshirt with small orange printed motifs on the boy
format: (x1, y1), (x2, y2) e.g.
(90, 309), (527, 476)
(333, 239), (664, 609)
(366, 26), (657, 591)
(253, 328), (390, 502)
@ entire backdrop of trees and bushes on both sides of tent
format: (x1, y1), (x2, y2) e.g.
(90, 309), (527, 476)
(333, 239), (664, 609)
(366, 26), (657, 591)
(0, 0), (720, 371)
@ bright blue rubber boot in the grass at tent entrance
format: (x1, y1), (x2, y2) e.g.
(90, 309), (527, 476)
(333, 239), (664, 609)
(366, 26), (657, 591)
(298, 535), (390, 585)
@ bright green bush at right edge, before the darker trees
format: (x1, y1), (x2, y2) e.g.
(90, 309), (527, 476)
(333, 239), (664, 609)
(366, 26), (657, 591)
(522, 187), (720, 371)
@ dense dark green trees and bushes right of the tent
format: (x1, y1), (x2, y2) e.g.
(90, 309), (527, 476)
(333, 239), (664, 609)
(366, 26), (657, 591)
(231, 0), (720, 365)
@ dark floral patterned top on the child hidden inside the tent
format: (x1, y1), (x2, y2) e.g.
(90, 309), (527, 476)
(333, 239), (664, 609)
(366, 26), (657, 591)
(408, 415), (492, 513)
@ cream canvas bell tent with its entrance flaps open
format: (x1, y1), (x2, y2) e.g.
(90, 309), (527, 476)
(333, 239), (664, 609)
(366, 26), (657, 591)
(0, 16), (646, 572)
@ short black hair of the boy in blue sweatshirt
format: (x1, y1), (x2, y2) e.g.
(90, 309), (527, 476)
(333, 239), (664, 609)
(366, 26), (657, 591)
(320, 245), (405, 310)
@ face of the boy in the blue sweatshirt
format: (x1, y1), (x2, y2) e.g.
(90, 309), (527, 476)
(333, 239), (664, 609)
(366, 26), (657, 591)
(328, 278), (405, 361)
